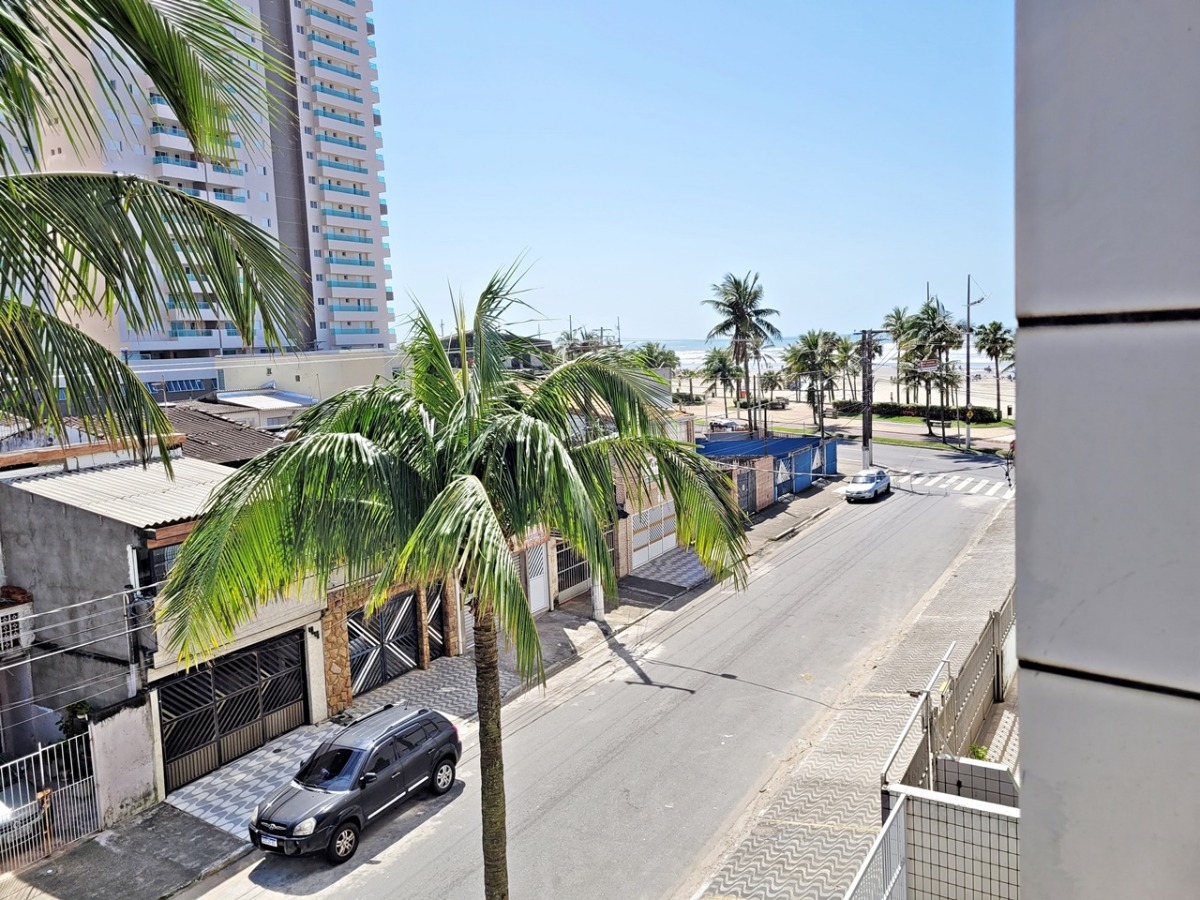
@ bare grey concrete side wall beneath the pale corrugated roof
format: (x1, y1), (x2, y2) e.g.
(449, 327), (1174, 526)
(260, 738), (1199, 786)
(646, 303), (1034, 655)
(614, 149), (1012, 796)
(0, 484), (137, 708)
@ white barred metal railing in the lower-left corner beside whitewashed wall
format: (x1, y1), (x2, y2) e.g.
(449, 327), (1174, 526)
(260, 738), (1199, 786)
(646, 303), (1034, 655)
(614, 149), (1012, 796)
(0, 733), (100, 871)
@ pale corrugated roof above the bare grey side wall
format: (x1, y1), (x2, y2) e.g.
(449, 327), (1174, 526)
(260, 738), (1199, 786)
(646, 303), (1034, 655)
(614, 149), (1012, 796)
(8, 458), (230, 528)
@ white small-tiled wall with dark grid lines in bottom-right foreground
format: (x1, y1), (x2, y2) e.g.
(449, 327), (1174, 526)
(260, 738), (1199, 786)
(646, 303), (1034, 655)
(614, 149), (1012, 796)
(904, 788), (1020, 900)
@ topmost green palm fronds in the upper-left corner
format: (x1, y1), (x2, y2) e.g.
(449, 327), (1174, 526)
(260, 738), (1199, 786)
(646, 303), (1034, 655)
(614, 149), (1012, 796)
(0, 0), (283, 172)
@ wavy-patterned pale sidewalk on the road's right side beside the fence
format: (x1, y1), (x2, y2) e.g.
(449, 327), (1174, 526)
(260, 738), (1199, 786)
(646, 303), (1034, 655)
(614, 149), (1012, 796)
(697, 504), (1015, 900)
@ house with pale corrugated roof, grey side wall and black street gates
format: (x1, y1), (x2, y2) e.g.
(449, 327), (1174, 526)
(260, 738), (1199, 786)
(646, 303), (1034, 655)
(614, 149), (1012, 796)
(0, 456), (461, 810)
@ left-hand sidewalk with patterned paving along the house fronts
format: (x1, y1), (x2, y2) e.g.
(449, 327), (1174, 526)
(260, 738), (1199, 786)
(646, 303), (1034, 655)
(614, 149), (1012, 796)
(0, 488), (842, 900)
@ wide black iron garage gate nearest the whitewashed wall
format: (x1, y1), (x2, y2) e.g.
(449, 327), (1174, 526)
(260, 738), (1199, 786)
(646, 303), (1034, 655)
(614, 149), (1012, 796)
(158, 631), (307, 793)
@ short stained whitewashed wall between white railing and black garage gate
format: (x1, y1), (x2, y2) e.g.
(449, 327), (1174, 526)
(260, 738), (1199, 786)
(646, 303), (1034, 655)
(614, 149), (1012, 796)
(91, 700), (162, 828)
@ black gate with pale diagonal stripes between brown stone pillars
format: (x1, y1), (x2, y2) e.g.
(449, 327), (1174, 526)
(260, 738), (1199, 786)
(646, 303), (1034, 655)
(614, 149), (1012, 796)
(346, 588), (445, 696)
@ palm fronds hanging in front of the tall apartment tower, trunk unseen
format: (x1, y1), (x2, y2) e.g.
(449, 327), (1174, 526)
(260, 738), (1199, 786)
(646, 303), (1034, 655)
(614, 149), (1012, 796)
(0, 0), (308, 458)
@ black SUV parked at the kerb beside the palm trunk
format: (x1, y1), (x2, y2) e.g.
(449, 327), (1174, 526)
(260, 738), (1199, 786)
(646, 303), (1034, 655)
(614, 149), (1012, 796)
(250, 703), (462, 864)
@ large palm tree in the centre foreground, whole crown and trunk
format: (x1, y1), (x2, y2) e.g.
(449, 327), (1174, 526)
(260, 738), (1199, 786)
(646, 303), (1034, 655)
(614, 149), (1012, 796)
(162, 266), (746, 900)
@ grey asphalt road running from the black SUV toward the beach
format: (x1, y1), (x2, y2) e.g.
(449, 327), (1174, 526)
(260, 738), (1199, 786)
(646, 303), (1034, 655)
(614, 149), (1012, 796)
(188, 460), (1002, 900)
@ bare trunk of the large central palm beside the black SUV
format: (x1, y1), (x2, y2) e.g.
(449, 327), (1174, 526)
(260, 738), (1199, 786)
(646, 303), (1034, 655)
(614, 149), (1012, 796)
(474, 600), (509, 900)
